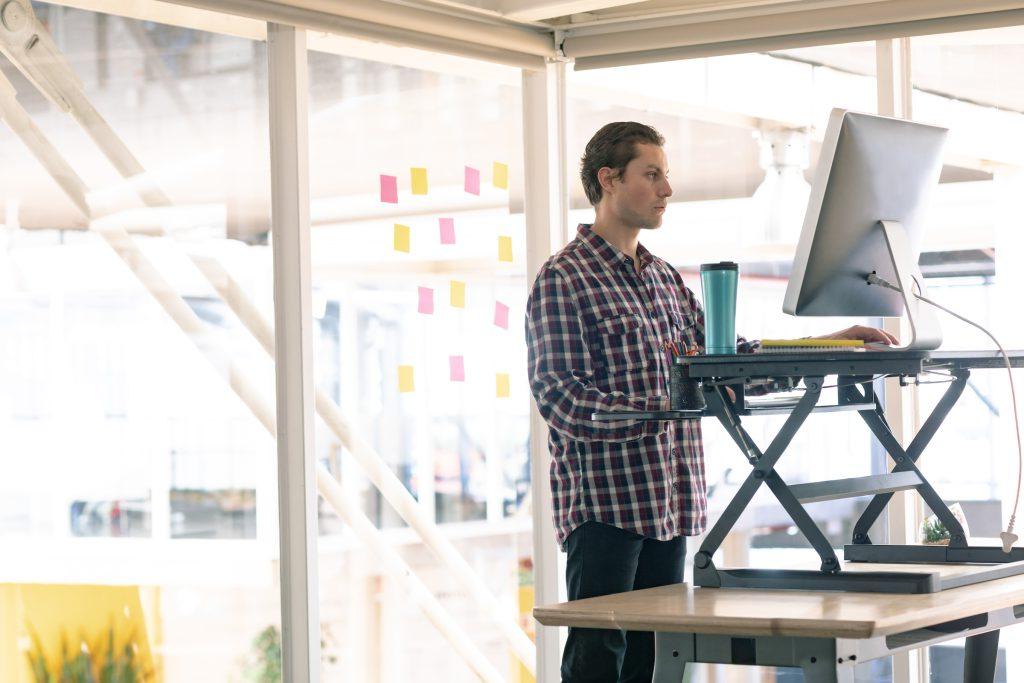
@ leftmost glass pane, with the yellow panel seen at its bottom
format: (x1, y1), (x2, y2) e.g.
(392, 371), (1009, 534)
(0, 3), (280, 682)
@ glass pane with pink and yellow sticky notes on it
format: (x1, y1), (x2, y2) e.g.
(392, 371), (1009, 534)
(301, 45), (532, 681)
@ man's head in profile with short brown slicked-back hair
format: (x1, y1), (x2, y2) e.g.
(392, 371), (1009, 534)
(580, 121), (672, 227)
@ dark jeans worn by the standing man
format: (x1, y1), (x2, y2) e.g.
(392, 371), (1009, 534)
(562, 521), (686, 683)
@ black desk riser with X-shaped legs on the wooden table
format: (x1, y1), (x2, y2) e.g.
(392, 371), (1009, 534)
(593, 351), (1024, 593)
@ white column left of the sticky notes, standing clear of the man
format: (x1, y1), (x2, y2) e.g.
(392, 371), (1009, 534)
(266, 24), (319, 683)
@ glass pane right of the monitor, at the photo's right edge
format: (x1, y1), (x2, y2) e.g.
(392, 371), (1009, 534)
(910, 28), (1024, 682)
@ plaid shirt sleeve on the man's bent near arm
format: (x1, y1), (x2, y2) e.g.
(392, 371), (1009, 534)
(526, 265), (668, 441)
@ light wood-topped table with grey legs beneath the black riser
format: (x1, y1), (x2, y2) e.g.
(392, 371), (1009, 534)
(534, 567), (1024, 683)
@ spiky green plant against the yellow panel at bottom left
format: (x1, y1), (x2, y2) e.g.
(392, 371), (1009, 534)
(28, 626), (153, 683)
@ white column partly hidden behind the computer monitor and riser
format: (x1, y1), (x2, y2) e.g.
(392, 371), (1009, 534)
(874, 38), (928, 683)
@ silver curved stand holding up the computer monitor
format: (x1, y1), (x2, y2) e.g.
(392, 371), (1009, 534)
(868, 220), (942, 351)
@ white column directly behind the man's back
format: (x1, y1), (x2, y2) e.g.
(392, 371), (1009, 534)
(522, 62), (568, 683)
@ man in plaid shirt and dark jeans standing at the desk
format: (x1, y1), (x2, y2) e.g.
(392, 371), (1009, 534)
(526, 122), (895, 683)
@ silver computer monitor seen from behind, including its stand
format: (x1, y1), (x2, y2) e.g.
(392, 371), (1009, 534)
(782, 109), (948, 349)
